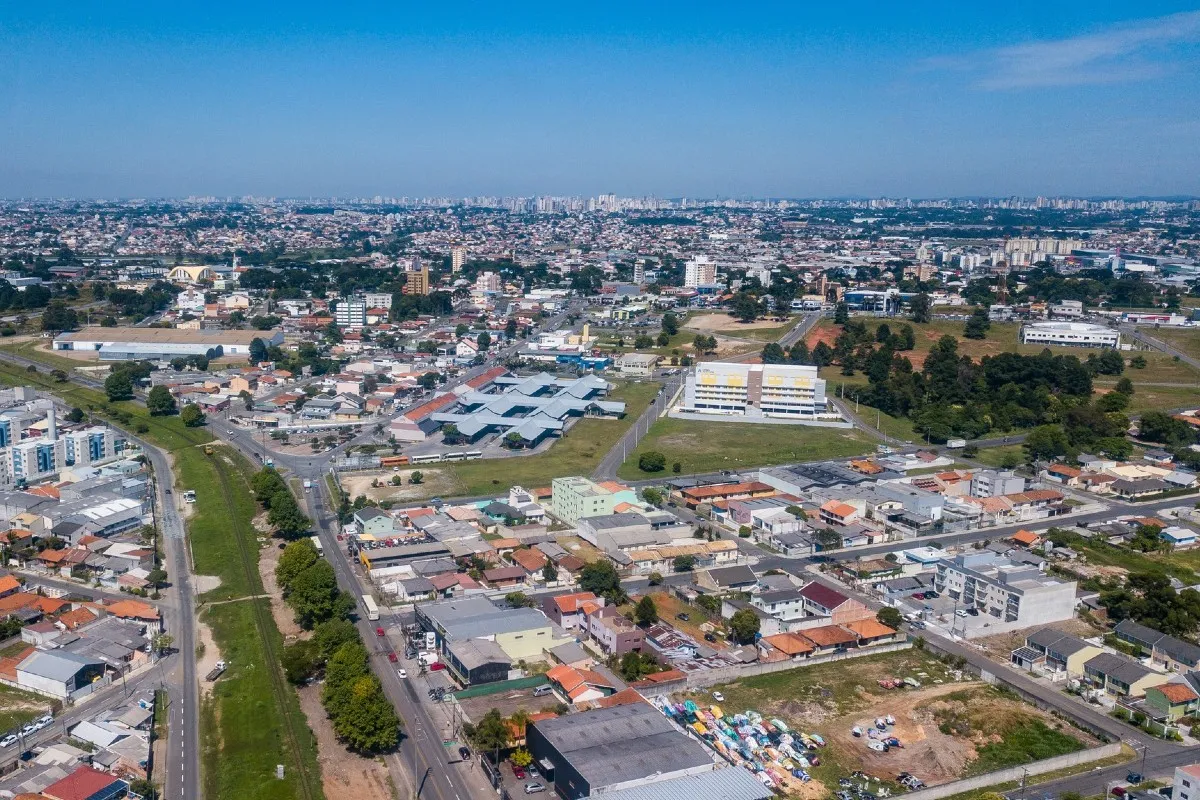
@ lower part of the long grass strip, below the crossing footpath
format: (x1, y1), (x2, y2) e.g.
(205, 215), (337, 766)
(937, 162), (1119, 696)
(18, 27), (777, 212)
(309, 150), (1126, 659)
(200, 600), (322, 800)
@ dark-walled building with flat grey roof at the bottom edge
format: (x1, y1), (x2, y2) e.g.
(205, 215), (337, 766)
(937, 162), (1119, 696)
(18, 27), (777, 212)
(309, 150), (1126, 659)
(526, 703), (715, 800)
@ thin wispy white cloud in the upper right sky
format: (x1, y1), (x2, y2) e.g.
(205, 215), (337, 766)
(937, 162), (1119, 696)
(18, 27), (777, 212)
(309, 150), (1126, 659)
(926, 11), (1200, 91)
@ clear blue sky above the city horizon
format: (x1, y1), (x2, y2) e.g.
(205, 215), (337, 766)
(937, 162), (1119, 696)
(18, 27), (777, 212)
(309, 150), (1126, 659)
(0, 0), (1200, 197)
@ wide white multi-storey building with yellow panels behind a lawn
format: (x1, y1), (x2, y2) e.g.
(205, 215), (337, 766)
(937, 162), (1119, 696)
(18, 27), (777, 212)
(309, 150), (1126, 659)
(678, 361), (840, 421)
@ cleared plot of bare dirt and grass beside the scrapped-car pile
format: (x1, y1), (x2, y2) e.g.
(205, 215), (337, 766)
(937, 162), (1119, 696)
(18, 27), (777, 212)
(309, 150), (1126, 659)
(696, 650), (1091, 796)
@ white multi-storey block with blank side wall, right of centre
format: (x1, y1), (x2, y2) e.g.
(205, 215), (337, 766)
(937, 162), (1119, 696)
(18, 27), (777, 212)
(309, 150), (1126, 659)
(934, 551), (1075, 637)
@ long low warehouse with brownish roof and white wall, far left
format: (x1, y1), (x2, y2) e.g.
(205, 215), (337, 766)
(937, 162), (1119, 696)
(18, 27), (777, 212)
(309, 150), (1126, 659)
(54, 325), (283, 361)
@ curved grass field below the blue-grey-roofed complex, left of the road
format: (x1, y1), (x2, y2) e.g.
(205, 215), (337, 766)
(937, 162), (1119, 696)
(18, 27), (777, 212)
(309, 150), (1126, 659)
(431, 383), (661, 497)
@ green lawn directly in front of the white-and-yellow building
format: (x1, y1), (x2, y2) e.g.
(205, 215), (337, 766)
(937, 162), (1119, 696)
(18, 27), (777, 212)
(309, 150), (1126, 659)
(617, 419), (875, 480)
